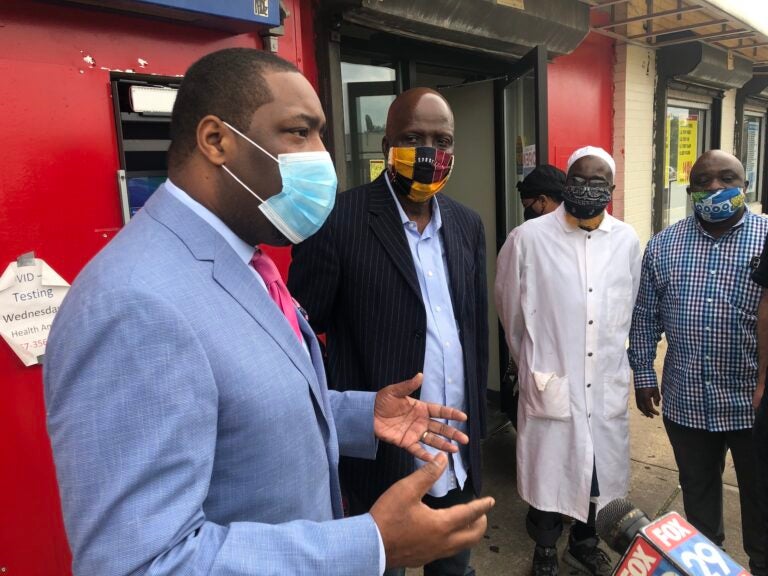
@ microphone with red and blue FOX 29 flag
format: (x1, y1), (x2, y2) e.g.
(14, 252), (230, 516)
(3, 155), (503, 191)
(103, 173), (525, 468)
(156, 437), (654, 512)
(595, 498), (749, 576)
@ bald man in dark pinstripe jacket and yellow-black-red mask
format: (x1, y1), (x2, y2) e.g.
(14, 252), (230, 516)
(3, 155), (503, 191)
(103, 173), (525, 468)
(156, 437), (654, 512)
(289, 88), (488, 576)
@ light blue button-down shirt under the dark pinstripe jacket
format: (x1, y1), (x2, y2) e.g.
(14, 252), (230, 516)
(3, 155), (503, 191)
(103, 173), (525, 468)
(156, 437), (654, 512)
(385, 179), (467, 498)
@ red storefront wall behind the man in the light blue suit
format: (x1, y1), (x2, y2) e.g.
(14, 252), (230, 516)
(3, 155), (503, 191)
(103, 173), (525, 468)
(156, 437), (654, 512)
(0, 0), (317, 576)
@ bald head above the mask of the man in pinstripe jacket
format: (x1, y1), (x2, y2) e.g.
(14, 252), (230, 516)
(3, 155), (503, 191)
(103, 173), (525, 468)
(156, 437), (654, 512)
(381, 88), (453, 156)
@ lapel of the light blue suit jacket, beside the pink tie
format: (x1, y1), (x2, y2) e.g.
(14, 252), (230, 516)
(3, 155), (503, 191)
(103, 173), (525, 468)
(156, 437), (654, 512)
(145, 188), (328, 420)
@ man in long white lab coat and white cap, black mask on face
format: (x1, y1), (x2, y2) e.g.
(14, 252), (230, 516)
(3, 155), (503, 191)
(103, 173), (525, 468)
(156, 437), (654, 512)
(496, 146), (640, 576)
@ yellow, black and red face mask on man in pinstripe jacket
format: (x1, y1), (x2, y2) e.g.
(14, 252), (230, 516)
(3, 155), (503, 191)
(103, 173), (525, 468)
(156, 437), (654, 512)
(387, 146), (453, 202)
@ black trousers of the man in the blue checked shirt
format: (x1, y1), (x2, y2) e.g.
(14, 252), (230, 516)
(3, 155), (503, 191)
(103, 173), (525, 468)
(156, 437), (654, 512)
(664, 418), (766, 573)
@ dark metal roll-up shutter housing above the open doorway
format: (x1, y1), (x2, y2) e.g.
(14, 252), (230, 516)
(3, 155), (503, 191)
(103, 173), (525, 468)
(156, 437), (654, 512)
(321, 0), (589, 59)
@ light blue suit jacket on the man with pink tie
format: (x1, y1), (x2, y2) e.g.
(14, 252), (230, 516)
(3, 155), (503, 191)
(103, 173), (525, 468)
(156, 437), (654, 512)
(45, 188), (379, 576)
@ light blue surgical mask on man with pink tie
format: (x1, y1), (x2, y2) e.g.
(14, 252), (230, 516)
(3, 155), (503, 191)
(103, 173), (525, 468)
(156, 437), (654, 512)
(221, 122), (338, 244)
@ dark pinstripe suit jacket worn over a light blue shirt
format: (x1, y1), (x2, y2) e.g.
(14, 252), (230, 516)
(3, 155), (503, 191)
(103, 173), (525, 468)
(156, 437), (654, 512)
(288, 175), (488, 513)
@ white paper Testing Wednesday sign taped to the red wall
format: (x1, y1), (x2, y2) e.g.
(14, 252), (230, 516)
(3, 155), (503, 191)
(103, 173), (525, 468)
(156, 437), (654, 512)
(0, 258), (69, 366)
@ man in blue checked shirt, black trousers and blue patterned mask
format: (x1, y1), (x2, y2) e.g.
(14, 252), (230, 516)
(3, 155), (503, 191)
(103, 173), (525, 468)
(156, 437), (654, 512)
(629, 150), (768, 576)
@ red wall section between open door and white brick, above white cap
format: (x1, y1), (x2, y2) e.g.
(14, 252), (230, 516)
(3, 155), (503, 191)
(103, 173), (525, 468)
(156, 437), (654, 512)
(547, 34), (614, 170)
